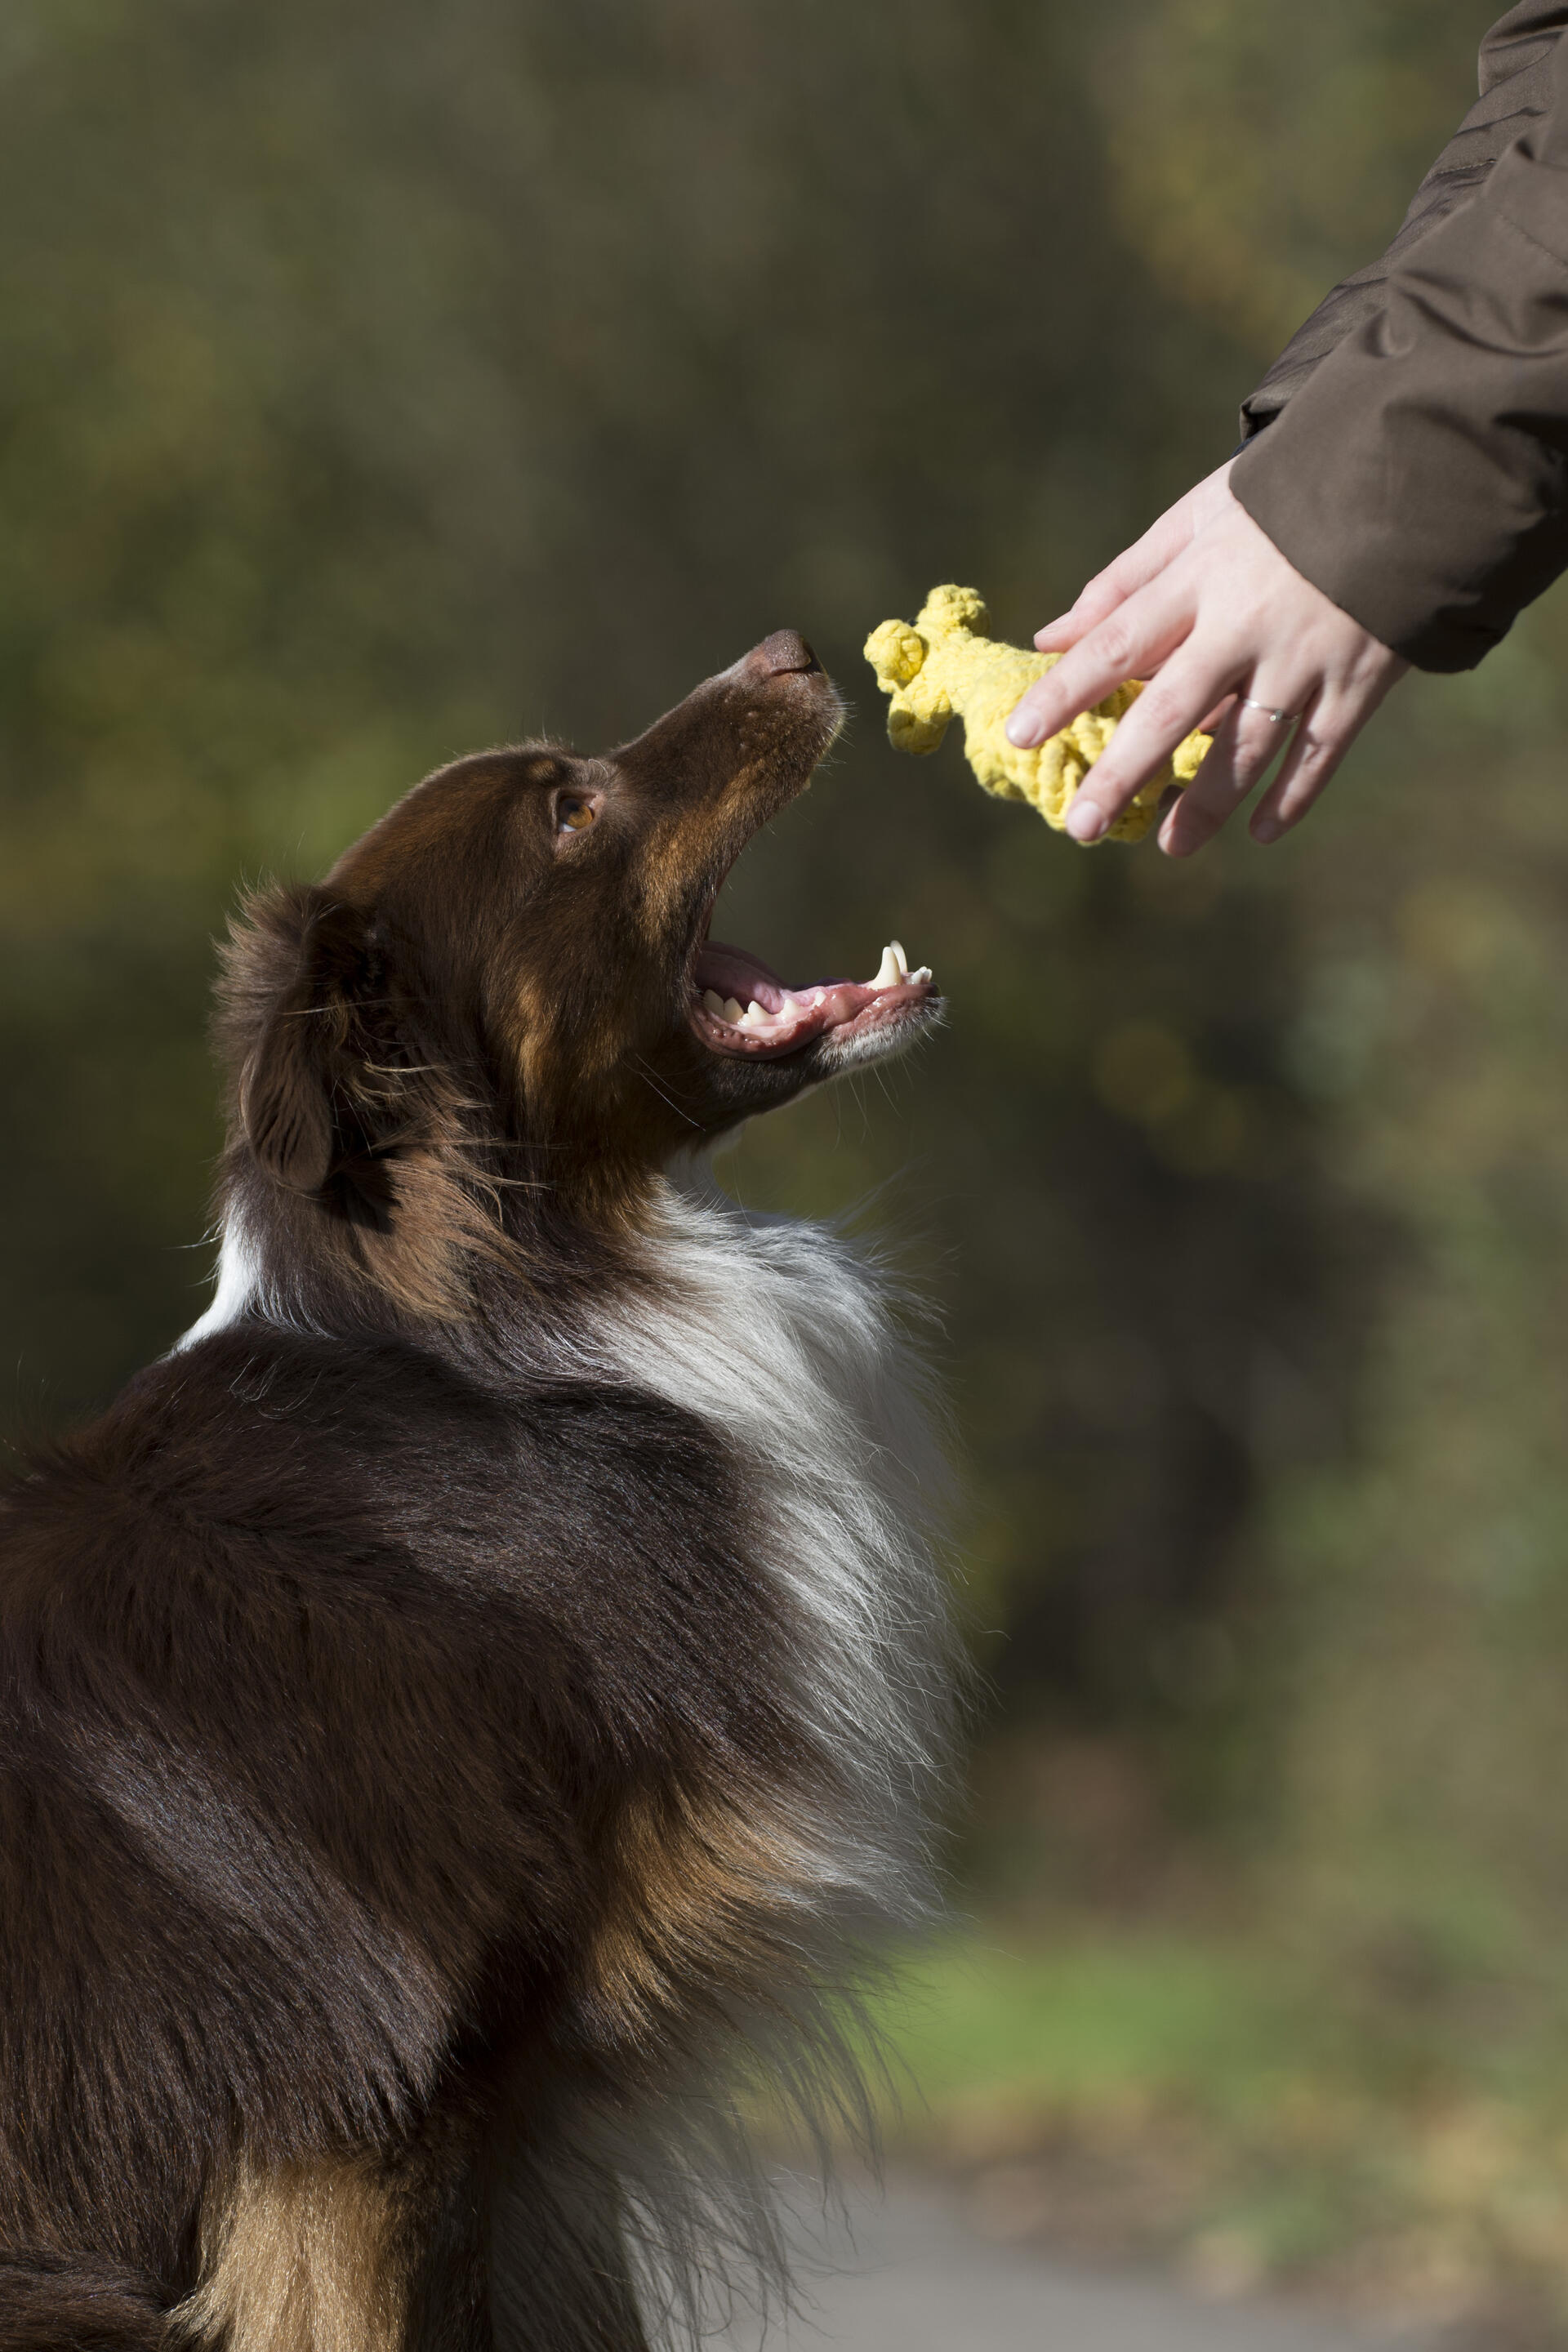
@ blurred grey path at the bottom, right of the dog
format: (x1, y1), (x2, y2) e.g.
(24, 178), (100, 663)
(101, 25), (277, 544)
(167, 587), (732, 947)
(726, 2180), (1437, 2352)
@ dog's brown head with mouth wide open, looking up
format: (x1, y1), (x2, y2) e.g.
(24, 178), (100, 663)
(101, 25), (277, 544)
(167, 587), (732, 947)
(221, 630), (938, 1307)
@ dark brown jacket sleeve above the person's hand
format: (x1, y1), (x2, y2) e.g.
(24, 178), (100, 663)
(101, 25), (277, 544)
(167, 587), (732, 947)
(1232, 0), (1568, 670)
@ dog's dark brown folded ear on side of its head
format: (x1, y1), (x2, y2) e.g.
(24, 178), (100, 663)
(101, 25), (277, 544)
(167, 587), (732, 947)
(240, 892), (399, 1225)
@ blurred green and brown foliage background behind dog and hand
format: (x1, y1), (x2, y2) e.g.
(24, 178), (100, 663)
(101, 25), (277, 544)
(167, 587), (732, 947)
(0, 0), (1568, 2345)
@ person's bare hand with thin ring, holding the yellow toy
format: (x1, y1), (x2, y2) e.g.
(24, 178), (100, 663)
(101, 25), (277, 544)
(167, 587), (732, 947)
(1006, 461), (1410, 858)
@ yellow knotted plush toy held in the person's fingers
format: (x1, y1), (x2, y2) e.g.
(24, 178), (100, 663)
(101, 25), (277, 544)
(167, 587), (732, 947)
(865, 588), (1209, 842)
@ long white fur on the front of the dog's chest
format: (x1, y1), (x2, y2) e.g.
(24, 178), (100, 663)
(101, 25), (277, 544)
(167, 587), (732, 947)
(597, 1190), (952, 1919)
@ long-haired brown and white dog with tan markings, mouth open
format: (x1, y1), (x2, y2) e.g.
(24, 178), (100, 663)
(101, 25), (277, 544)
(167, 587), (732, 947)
(0, 633), (947, 2352)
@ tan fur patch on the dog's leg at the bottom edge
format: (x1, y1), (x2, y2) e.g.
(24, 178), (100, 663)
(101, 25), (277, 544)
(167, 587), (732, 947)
(172, 2157), (409, 2352)
